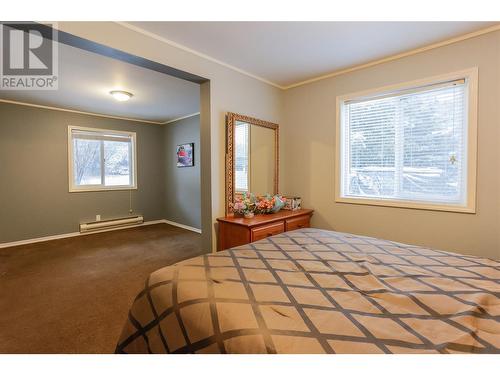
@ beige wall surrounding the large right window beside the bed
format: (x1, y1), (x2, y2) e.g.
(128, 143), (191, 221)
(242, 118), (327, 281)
(281, 32), (500, 259)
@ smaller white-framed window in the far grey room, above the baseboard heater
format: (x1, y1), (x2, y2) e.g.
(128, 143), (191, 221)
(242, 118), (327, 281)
(68, 126), (137, 191)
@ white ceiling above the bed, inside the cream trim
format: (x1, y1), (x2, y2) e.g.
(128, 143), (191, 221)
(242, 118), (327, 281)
(130, 22), (495, 86)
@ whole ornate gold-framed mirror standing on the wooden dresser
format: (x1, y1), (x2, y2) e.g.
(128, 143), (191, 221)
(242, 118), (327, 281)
(226, 112), (279, 214)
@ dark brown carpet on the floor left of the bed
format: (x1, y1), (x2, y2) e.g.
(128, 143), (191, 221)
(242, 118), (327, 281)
(0, 224), (202, 353)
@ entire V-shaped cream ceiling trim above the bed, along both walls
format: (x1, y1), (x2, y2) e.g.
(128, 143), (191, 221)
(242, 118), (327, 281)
(116, 22), (500, 90)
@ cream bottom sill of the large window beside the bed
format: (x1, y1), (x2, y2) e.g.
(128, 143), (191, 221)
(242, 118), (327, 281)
(335, 197), (476, 214)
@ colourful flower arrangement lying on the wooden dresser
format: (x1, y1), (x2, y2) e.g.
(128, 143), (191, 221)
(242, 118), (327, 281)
(232, 193), (286, 218)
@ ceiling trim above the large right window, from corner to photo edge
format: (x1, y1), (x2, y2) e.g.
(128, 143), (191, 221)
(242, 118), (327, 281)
(283, 24), (500, 90)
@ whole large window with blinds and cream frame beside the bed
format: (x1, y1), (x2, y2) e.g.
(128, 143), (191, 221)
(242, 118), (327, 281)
(337, 70), (476, 212)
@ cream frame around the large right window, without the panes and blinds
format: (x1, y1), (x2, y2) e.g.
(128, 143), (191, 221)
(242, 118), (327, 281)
(334, 67), (478, 213)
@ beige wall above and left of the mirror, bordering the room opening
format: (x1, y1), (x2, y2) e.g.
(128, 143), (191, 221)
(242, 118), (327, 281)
(58, 22), (283, 253)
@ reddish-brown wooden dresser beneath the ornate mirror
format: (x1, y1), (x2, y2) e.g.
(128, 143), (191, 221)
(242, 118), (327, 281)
(217, 209), (313, 251)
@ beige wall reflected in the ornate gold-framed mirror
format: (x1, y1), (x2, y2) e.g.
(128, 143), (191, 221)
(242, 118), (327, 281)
(250, 125), (276, 195)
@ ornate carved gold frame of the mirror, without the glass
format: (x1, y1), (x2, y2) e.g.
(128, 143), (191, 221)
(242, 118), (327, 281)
(225, 112), (280, 215)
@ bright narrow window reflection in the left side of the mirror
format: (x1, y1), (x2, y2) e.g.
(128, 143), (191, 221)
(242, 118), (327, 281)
(234, 122), (250, 192)
